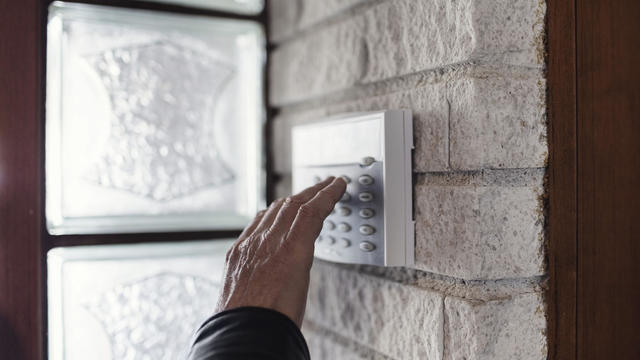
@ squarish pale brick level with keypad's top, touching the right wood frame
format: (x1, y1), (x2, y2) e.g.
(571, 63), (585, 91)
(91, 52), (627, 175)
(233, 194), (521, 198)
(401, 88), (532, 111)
(447, 74), (547, 170)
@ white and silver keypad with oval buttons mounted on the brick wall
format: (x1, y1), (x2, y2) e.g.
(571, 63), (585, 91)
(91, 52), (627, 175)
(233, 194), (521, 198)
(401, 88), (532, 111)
(291, 110), (415, 266)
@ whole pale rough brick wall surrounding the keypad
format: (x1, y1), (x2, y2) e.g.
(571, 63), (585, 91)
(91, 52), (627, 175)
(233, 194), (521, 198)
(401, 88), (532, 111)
(269, 0), (548, 360)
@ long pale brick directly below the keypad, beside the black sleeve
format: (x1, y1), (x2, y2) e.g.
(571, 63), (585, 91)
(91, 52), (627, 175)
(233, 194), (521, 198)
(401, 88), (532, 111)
(305, 260), (443, 360)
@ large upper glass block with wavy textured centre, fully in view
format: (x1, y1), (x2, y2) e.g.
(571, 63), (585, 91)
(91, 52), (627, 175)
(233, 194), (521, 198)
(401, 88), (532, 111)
(46, 2), (265, 234)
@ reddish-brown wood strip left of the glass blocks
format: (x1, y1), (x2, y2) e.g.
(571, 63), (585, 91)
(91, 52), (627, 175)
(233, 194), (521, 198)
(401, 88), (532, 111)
(0, 0), (43, 360)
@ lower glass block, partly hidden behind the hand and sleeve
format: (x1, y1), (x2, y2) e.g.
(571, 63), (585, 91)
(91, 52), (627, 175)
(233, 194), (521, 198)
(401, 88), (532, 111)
(47, 240), (233, 360)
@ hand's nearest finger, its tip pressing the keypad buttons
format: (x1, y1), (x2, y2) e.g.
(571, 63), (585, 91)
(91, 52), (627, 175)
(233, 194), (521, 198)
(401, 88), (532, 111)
(287, 178), (347, 243)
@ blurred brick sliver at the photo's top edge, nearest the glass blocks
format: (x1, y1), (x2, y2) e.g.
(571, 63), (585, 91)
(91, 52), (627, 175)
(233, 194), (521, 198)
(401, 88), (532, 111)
(268, 0), (372, 42)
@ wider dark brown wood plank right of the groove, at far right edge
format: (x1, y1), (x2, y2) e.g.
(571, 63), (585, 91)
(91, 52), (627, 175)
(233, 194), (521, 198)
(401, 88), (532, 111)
(577, 0), (640, 359)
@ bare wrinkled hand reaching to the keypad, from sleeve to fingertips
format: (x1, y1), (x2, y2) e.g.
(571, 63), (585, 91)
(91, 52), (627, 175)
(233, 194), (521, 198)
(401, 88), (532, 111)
(216, 177), (347, 327)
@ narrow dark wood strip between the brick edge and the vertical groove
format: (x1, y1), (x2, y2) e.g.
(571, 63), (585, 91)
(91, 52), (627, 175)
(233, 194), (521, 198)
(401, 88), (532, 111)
(547, 0), (577, 359)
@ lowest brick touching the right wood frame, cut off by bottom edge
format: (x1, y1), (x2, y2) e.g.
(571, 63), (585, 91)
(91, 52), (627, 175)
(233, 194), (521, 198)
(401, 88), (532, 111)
(444, 294), (547, 360)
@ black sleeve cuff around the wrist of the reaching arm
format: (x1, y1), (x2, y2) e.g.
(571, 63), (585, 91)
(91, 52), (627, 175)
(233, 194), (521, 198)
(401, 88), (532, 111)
(189, 307), (311, 360)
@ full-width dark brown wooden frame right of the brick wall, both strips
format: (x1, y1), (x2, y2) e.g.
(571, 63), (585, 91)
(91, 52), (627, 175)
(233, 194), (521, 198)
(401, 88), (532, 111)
(547, 0), (640, 359)
